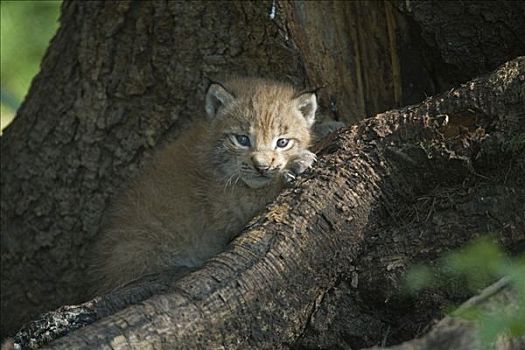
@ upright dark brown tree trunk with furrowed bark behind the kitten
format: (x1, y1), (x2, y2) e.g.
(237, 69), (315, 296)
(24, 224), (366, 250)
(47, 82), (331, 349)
(1, 1), (523, 344)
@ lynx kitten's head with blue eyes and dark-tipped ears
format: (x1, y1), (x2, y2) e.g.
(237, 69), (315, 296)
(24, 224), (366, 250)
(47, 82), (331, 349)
(206, 79), (317, 188)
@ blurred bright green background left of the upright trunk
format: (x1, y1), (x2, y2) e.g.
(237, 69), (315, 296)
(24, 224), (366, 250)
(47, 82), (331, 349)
(0, 0), (62, 130)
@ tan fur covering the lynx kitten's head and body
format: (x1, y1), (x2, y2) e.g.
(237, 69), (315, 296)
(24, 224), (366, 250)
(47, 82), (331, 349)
(90, 79), (316, 292)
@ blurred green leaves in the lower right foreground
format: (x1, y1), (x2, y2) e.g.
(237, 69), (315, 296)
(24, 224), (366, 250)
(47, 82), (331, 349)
(406, 239), (525, 344)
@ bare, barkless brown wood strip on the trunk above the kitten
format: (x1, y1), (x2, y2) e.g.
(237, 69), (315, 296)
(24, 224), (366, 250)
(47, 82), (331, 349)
(282, 1), (406, 122)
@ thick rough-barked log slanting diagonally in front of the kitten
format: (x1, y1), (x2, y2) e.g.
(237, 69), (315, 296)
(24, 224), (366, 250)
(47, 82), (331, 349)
(9, 58), (525, 349)
